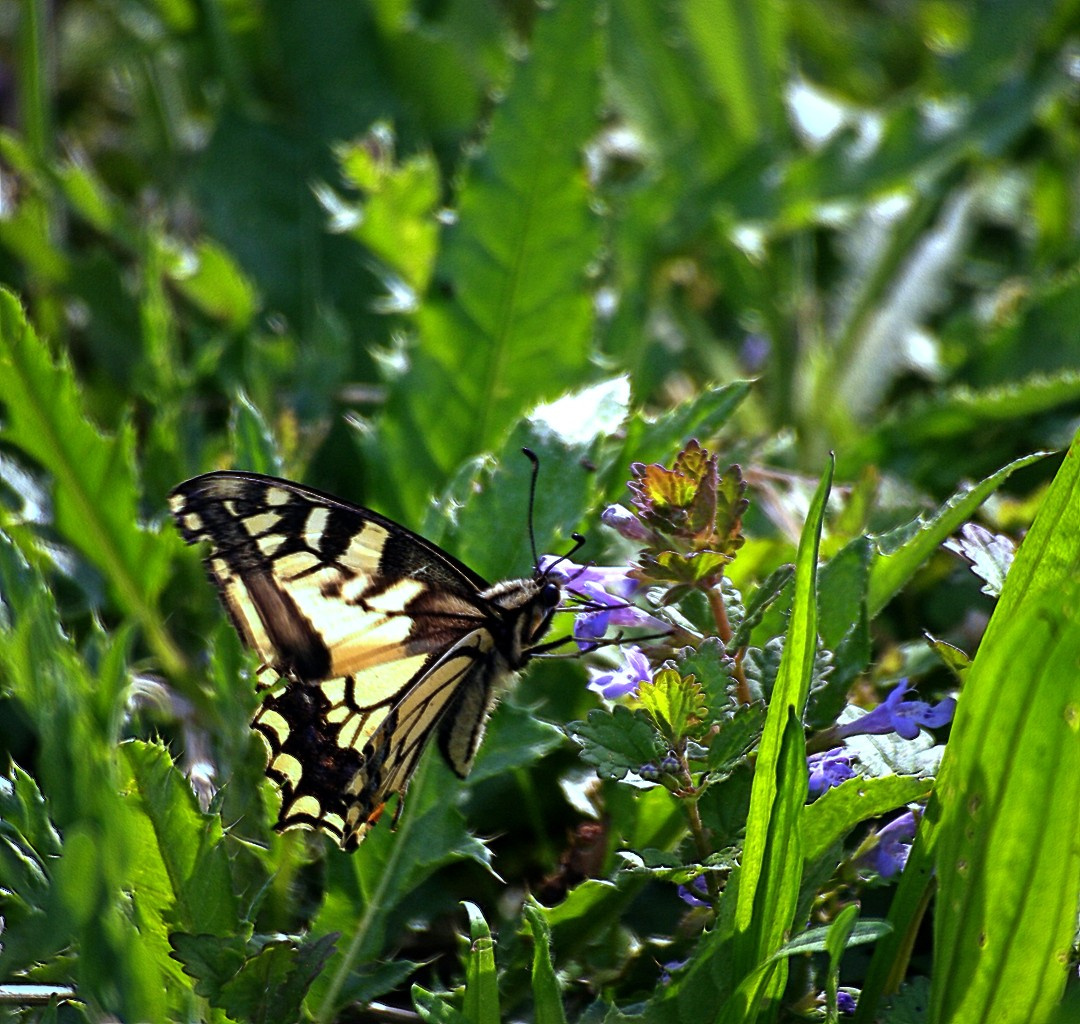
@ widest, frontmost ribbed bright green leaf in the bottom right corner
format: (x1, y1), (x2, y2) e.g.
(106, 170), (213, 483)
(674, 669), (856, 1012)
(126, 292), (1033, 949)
(931, 583), (1080, 1024)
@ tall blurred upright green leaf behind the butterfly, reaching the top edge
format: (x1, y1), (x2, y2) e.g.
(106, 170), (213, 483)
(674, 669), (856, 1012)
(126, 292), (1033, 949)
(370, 3), (599, 512)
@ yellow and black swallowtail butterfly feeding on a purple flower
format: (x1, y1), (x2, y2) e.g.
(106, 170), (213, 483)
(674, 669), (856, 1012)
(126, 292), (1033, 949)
(170, 468), (563, 850)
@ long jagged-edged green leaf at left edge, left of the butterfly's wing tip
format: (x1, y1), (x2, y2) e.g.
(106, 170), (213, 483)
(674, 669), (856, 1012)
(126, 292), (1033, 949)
(0, 291), (183, 675)
